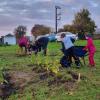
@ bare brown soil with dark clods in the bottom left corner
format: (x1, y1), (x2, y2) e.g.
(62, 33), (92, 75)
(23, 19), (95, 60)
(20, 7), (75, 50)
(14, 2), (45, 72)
(0, 71), (37, 99)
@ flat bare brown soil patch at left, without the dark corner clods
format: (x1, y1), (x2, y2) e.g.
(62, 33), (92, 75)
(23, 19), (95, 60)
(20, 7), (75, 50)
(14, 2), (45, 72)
(3, 71), (37, 89)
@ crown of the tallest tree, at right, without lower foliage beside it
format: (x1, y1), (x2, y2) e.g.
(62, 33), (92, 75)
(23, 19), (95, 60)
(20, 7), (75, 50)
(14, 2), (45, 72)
(73, 9), (96, 33)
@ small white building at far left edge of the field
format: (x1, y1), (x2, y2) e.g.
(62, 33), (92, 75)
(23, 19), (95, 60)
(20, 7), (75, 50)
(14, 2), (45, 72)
(3, 34), (16, 45)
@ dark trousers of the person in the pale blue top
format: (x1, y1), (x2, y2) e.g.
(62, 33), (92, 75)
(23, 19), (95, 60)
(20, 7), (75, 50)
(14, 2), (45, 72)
(64, 46), (80, 66)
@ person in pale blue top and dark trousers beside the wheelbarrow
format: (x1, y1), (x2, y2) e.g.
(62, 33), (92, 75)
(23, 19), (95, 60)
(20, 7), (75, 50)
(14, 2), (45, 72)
(61, 33), (79, 68)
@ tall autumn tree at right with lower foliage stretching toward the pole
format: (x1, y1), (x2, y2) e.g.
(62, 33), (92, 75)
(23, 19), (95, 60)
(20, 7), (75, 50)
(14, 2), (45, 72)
(58, 9), (96, 38)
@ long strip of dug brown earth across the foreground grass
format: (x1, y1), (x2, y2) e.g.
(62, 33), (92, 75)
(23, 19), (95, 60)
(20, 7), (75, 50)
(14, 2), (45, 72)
(0, 69), (86, 99)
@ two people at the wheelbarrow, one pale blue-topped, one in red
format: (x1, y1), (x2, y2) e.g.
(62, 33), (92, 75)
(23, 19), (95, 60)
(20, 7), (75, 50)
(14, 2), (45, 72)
(61, 32), (96, 68)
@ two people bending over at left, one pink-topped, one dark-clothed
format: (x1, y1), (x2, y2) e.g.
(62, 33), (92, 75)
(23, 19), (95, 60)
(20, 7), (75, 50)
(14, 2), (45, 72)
(18, 36), (49, 55)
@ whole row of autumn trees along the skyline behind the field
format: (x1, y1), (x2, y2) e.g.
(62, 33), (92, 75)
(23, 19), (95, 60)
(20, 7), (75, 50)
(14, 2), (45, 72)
(14, 9), (96, 38)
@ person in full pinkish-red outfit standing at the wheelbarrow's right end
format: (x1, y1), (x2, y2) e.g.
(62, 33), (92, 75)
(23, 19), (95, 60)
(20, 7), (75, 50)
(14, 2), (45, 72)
(83, 35), (96, 67)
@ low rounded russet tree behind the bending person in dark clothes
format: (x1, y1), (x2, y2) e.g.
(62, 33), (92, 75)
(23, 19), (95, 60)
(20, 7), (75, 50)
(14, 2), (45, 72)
(31, 24), (51, 37)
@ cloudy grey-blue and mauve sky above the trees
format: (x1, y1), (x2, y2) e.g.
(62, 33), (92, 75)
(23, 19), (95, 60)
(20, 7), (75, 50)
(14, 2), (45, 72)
(0, 0), (100, 35)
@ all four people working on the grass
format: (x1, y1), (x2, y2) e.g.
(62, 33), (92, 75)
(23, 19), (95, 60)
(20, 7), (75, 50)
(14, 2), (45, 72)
(18, 33), (96, 68)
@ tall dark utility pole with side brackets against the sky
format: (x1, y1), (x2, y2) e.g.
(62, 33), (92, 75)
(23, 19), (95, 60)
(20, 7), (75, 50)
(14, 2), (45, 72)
(55, 6), (61, 34)
